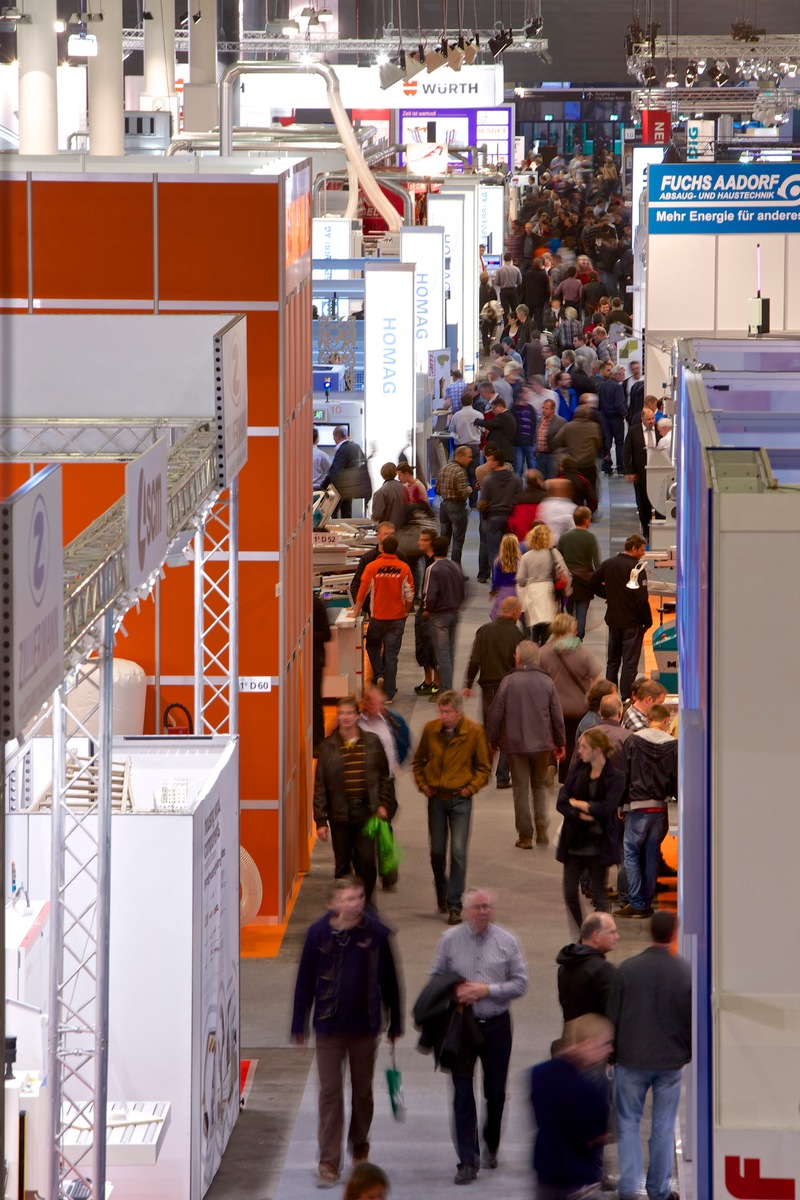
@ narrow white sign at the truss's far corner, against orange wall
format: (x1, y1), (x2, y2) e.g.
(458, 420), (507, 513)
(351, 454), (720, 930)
(213, 317), (247, 488)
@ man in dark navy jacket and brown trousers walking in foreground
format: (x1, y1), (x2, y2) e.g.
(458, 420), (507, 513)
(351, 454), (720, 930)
(291, 876), (403, 1188)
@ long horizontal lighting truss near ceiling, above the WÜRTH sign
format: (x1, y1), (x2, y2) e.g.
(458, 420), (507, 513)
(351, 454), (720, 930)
(122, 26), (548, 60)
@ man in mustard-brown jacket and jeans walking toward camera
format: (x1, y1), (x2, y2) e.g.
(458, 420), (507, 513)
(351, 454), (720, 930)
(414, 691), (492, 925)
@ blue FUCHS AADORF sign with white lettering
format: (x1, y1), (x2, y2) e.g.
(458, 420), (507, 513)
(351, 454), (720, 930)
(648, 163), (800, 234)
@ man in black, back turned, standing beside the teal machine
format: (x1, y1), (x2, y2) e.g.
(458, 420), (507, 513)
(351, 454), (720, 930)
(589, 533), (652, 700)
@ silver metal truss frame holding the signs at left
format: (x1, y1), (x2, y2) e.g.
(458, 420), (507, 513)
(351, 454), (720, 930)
(0, 420), (239, 1200)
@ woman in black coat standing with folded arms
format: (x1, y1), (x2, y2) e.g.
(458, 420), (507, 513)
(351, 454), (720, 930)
(555, 726), (625, 929)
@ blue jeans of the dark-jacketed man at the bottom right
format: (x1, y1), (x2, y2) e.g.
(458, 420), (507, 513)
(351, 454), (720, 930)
(614, 1064), (681, 1200)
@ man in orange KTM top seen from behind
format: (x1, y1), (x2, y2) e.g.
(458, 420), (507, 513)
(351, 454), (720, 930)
(353, 536), (414, 700)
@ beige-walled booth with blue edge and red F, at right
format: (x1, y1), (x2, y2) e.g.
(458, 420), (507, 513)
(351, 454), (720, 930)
(674, 336), (800, 1198)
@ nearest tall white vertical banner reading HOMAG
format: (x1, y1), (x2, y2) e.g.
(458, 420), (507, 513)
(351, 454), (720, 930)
(363, 259), (415, 477)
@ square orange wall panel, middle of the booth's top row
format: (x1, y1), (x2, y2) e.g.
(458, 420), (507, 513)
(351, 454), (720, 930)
(32, 176), (154, 300)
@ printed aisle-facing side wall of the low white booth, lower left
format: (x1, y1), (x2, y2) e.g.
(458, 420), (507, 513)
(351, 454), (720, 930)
(197, 758), (239, 1193)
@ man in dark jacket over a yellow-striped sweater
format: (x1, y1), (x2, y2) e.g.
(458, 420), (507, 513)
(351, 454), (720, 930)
(314, 696), (397, 904)
